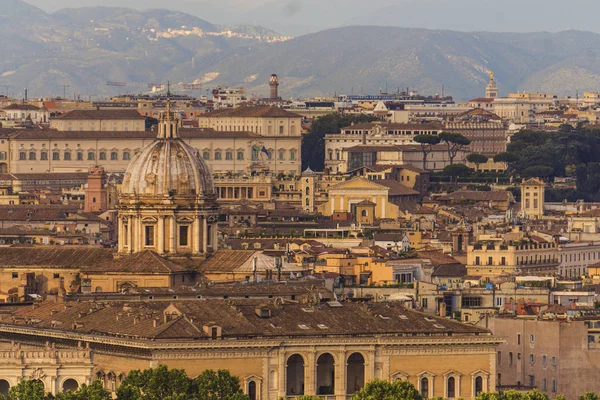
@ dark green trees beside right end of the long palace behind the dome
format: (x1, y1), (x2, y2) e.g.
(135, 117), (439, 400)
(301, 114), (377, 171)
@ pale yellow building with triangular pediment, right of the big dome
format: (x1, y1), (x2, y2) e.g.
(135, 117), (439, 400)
(319, 178), (398, 218)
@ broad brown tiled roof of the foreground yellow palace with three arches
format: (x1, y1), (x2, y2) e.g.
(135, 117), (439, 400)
(5, 299), (489, 344)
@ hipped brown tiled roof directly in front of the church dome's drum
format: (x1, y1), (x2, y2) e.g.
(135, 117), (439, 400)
(82, 251), (185, 274)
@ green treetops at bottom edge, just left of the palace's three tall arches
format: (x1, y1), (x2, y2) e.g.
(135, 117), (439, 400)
(117, 365), (248, 400)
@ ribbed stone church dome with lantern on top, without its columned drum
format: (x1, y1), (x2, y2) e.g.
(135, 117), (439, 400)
(121, 103), (214, 197)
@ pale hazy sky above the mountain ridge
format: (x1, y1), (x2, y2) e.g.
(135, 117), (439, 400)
(21, 0), (600, 35)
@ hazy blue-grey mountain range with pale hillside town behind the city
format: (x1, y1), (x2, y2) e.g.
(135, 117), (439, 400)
(0, 0), (600, 100)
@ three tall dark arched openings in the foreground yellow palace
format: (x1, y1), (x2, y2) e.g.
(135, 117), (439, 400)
(286, 353), (365, 400)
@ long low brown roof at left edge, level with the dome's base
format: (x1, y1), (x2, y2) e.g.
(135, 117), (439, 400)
(0, 246), (114, 268)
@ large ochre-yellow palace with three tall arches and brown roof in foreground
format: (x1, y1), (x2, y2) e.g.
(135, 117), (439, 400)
(0, 296), (502, 400)
